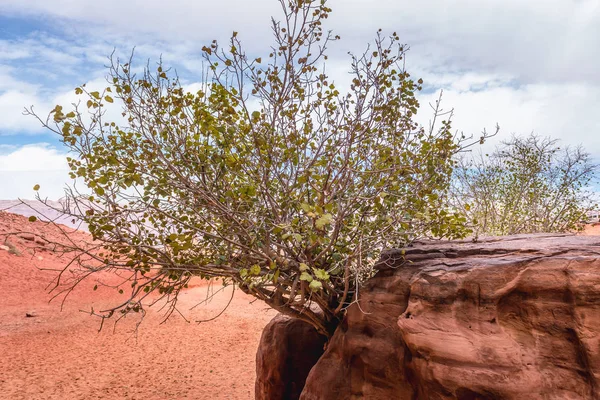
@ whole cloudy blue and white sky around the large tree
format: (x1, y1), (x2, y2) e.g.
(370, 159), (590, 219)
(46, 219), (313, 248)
(0, 0), (600, 199)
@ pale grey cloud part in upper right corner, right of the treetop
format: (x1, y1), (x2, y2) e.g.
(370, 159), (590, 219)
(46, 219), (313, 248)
(332, 0), (600, 83)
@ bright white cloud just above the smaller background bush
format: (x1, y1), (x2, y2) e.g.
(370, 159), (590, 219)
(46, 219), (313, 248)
(419, 83), (600, 156)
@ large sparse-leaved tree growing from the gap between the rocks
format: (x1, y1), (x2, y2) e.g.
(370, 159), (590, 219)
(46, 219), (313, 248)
(29, 0), (486, 334)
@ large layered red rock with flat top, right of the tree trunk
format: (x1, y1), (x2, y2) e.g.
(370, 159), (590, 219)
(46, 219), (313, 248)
(301, 235), (600, 400)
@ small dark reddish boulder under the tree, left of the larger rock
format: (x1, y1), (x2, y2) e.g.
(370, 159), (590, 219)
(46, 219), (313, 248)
(255, 314), (326, 400)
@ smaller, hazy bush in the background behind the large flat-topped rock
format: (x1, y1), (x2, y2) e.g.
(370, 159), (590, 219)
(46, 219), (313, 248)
(453, 134), (597, 235)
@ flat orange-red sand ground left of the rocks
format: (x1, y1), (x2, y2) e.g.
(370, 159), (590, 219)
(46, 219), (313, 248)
(0, 212), (275, 399)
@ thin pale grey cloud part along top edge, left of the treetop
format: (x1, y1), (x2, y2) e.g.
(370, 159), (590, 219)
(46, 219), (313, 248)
(0, 0), (279, 43)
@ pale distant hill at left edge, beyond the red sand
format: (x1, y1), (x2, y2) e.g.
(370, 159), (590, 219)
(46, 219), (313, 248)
(0, 200), (87, 232)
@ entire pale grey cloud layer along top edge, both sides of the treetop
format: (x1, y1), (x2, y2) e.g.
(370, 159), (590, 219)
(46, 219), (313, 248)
(0, 0), (600, 82)
